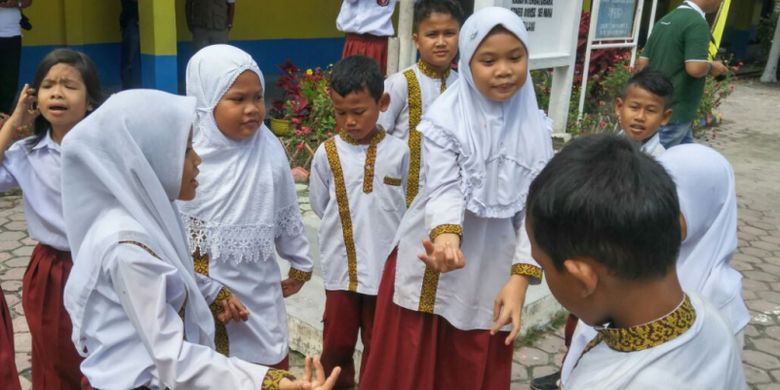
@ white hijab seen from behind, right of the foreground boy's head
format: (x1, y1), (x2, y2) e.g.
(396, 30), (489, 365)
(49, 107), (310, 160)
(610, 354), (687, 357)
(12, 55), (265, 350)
(658, 144), (750, 334)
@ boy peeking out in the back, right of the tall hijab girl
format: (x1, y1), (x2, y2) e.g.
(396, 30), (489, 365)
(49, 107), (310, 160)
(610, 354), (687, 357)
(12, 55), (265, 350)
(615, 69), (674, 157)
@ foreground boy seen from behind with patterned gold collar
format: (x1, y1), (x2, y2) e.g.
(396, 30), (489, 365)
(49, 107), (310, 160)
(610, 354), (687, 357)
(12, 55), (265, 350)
(526, 136), (746, 389)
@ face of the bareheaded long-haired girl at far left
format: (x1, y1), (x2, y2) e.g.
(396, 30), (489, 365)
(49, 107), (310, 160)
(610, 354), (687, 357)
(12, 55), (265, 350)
(37, 63), (92, 136)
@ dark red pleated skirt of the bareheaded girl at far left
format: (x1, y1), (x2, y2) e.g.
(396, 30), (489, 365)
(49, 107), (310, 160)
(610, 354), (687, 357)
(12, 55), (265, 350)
(22, 244), (89, 390)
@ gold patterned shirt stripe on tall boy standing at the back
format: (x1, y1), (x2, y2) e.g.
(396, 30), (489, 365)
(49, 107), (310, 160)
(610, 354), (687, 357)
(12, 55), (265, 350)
(404, 69), (422, 207)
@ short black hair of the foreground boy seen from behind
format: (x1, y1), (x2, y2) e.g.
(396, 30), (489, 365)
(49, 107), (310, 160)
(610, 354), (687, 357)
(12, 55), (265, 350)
(526, 135), (681, 280)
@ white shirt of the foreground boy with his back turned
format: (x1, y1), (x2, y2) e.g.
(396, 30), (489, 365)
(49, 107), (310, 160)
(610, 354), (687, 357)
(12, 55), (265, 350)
(562, 294), (747, 390)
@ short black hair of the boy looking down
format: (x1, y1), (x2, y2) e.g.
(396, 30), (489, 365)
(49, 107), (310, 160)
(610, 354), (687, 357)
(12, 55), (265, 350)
(330, 55), (385, 101)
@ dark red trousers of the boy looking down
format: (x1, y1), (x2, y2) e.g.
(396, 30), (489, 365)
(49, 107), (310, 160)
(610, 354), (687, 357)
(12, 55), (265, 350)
(320, 290), (376, 389)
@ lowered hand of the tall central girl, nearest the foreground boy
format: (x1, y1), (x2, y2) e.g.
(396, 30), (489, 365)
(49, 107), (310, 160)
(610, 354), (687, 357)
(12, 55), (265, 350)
(490, 275), (530, 345)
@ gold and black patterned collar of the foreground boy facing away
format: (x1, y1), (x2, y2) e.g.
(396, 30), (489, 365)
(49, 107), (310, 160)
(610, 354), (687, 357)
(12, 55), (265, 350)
(585, 295), (696, 352)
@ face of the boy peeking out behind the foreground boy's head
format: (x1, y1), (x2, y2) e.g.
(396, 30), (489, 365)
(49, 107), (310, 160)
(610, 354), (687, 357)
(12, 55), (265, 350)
(615, 85), (672, 142)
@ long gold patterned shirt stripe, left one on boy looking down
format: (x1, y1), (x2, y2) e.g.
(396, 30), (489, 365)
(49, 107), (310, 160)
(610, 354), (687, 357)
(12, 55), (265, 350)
(325, 137), (357, 292)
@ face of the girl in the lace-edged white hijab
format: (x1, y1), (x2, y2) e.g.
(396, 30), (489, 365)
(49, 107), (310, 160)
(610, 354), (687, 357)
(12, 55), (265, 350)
(214, 70), (265, 141)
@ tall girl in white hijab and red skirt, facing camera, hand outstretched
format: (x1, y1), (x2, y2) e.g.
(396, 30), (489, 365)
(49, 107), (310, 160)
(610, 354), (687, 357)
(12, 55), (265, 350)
(361, 7), (552, 389)
